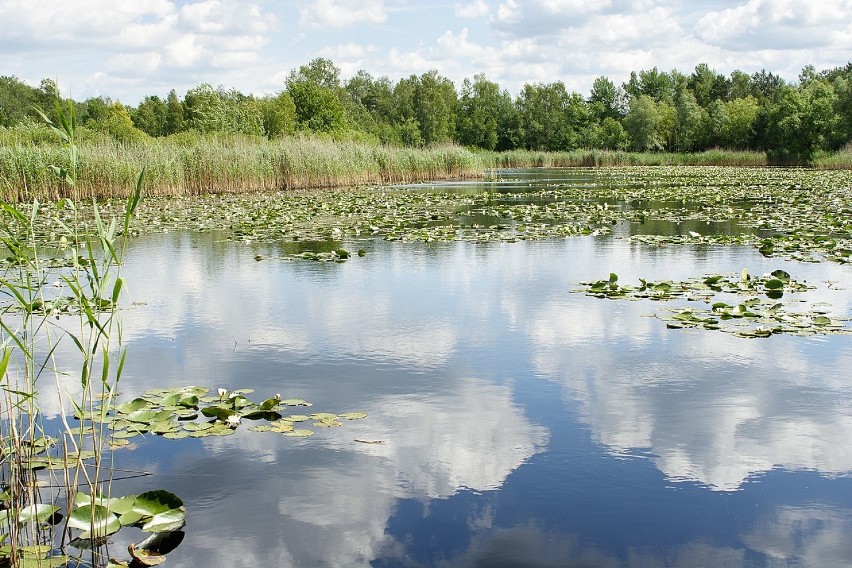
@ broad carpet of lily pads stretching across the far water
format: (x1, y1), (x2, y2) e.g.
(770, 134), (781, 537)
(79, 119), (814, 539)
(10, 166), (852, 263)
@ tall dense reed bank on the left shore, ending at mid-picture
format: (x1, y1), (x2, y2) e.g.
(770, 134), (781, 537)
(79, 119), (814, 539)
(0, 129), (485, 201)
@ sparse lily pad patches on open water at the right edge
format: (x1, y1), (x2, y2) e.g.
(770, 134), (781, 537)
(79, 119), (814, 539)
(579, 270), (852, 337)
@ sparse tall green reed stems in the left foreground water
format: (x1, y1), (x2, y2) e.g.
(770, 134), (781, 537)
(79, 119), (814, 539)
(0, 100), (142, 566)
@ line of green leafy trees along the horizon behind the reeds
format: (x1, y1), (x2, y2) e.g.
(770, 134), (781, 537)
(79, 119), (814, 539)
(0, 58), (852, 163)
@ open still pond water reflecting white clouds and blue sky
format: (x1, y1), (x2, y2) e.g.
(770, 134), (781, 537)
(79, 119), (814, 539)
(60, 176), (852, 568)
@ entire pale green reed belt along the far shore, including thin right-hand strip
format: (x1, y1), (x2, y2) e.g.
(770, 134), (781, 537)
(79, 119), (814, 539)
(0, 124), (852, 202)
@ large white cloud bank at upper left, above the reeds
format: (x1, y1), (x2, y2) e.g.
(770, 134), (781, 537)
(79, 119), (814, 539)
(0, 0), (277, 96)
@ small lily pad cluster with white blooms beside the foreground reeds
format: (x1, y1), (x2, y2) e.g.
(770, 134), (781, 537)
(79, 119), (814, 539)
(86, 386), (367, 447)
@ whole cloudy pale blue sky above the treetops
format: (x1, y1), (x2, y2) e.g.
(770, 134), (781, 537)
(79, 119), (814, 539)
(0, 0), (852, 105)
